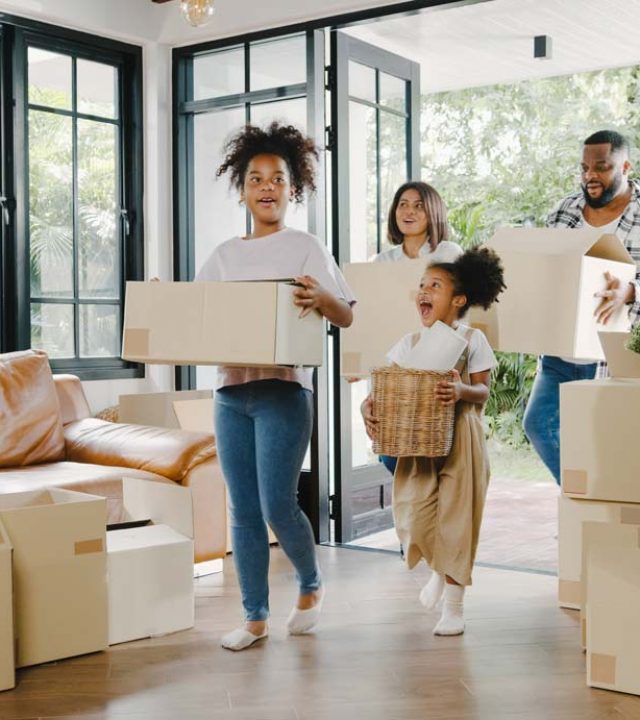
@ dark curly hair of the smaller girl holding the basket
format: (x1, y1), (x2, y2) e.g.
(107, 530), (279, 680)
(429, 247), (507, 317)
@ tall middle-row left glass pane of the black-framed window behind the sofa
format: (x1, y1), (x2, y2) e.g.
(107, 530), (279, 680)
(29, 110), (73, 297)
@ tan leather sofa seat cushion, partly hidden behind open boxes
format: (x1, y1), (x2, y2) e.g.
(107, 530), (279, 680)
(0, 462), (173, 522)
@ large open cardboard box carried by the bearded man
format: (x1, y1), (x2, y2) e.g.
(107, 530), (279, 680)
(470, 228), (636, 359)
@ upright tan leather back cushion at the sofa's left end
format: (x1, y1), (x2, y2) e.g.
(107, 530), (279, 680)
(0, 350), (65, 467)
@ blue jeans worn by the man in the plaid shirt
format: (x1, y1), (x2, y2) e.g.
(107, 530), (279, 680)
(523, 355), (598, 485)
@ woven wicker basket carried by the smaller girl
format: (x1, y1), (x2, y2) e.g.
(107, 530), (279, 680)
(371, 367), (455, 457)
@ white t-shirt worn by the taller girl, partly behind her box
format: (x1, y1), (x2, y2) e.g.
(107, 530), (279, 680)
(195, 228), (355, 390)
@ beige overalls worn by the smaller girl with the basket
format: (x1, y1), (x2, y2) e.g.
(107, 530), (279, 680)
(393, 331), (489, 585)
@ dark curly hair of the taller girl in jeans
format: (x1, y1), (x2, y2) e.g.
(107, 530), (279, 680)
(216, 121), (318, 203)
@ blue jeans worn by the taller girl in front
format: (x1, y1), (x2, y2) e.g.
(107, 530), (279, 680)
(214, 380), (321, 621)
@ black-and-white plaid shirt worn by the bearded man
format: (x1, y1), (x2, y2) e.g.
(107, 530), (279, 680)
(545, 181), (640, 325)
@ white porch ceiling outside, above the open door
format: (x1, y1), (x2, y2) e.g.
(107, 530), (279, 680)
(346, 0), (640, 94)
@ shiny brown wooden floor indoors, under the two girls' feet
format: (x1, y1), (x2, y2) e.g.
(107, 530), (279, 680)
(0, 548), (640, 720)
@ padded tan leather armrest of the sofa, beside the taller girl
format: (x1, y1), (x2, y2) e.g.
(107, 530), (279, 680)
(64, 418), (216, 483)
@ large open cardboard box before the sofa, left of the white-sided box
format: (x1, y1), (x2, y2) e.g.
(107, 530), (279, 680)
(0, 489), (107, 667)
